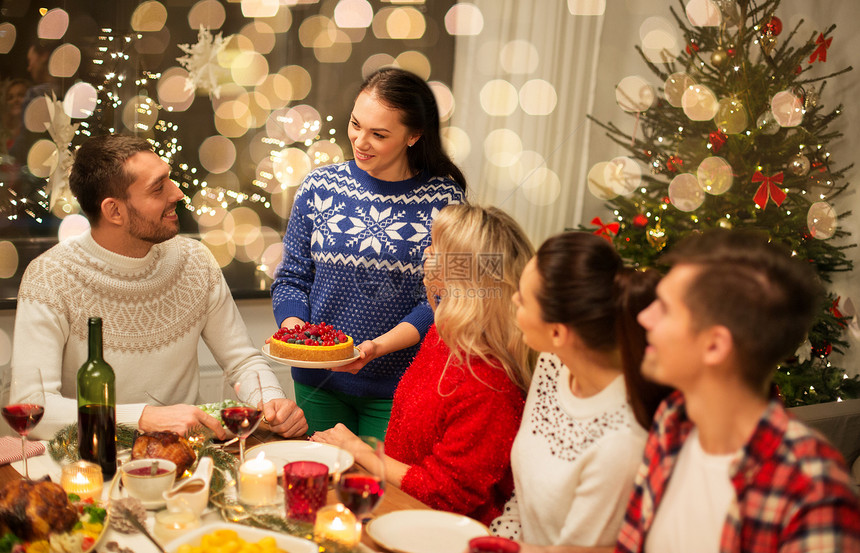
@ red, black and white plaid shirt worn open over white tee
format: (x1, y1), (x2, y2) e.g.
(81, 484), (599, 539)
(615, 392), (860, 553)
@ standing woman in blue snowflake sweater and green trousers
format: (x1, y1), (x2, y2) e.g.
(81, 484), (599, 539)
(272, 68), (466, 438)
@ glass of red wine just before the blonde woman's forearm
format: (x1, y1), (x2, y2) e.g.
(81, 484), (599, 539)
(335, 436), (385, 522)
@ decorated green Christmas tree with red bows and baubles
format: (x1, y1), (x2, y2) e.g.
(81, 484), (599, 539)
(588, 0), (860, 406)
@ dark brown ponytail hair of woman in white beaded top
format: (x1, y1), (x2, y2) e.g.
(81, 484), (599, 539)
(536, 232), (670, 429)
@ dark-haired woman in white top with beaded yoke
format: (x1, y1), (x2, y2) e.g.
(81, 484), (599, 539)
(491, 232), (666, 553)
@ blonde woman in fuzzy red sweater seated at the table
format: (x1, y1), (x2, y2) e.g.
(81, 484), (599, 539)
(311, 205), (534, 524)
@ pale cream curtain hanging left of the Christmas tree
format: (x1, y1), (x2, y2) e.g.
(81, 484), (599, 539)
(449, 0), (613, 245)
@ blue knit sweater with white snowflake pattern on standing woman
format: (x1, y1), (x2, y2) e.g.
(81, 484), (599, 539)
(272, 162), (465, 398)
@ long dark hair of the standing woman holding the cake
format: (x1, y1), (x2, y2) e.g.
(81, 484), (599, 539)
(359, 67), (466, 192)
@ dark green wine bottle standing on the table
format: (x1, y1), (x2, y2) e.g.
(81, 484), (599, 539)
(78, 317), (116, 477)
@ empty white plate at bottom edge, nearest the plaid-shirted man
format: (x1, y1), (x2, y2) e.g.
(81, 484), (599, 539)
(367, 509), (490, 553)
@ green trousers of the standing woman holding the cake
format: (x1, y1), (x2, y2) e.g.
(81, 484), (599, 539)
(293, 382), (391, 440)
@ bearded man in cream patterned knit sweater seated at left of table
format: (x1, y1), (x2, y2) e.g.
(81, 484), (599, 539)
(11, 135), (307, 439)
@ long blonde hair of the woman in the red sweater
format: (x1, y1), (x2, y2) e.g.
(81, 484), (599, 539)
(432, 205), (536, 390)
